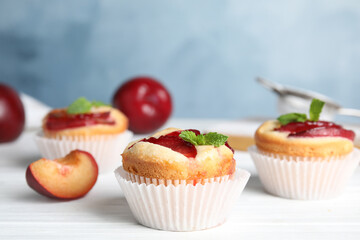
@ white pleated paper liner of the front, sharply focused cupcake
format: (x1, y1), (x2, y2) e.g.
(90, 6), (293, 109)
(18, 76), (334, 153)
(115, 167), (250, 231)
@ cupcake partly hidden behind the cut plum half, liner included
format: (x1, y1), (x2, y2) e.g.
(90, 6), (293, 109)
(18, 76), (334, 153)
(35, 97), (132, 173)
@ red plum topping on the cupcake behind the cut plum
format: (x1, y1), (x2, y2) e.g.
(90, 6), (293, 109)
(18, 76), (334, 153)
(46, 110), (115, 130)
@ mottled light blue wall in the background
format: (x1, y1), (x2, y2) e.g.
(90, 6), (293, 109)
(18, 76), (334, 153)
(0, 0), (360, 118)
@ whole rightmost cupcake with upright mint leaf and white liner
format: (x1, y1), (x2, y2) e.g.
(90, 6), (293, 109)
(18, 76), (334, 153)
(249, 99), (360, 200)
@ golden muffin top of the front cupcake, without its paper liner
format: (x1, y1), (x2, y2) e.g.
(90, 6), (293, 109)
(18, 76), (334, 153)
(122, 128), (235, 180)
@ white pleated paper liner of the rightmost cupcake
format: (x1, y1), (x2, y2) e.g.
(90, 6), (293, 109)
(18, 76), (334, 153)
(248, 146), (360, 200)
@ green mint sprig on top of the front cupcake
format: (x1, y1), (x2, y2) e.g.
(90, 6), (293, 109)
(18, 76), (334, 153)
(179, 131), (228, 147)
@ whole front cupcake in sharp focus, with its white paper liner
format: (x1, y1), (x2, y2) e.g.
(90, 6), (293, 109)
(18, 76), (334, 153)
(115, 128), (250, 231)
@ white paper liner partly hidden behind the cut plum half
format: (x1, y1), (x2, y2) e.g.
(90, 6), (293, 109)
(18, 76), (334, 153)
(35, 131), (133, 173)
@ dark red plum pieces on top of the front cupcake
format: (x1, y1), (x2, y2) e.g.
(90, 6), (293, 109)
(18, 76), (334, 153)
(129, 129), (234, 158)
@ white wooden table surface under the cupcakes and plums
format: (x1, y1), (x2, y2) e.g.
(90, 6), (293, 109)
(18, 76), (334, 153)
(0, 119), (360, 240)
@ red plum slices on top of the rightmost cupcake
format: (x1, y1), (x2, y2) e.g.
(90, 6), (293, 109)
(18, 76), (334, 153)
(275, 121), (355, 141)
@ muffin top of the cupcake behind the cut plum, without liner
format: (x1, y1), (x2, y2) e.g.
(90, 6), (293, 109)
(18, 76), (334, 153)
(42, 98), (128, 138)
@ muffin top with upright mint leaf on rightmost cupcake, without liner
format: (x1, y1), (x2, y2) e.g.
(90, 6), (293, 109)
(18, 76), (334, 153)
(255, 99), (355, 157)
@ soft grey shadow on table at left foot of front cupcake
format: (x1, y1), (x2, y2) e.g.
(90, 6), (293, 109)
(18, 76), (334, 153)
(86, 196), (137, 224)
